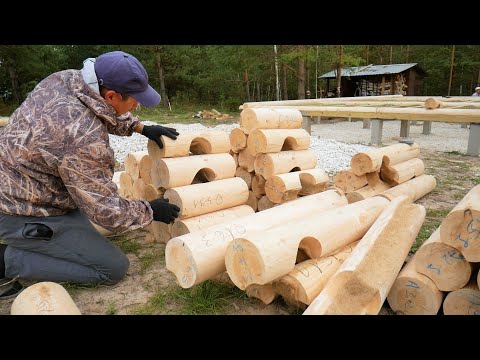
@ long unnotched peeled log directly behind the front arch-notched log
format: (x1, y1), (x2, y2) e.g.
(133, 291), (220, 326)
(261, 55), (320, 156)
(165, 190), (347, 288)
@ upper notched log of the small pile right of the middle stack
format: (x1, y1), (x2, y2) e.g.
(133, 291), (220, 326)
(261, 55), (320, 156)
(350, 144), (420, 176)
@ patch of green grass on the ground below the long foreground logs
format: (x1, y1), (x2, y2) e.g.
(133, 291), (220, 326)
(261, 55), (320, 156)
(132, 280), (246, 315)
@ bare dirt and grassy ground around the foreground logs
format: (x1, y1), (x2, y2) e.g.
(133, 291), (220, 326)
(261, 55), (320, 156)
(0, 150), (480, 315)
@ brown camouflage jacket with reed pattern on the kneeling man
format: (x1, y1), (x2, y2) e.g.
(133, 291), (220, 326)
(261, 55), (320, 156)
(0, 70), (153, 233)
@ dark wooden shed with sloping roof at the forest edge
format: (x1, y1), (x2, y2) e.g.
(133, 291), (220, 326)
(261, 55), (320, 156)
(320, 63), (427, 97)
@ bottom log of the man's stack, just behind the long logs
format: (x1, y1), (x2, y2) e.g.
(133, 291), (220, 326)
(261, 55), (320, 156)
(171, 205), (255, 237)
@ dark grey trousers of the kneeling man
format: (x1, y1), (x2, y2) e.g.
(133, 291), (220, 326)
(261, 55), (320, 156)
(0, 210), (129, 285)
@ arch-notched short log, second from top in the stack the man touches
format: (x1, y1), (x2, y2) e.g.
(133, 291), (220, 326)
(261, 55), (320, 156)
(151, 153), (235, 189)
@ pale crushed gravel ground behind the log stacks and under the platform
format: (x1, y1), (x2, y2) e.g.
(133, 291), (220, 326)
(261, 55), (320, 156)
(110, 121), (469, 175)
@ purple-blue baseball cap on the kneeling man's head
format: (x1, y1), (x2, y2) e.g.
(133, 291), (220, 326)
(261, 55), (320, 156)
(95, 51), (161, 108)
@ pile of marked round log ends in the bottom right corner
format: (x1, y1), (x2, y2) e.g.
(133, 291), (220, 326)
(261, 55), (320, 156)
(387, 185), (480, 315)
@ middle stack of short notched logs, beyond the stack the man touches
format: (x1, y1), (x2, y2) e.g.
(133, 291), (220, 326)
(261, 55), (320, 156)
(230, 108), (329, 211)
